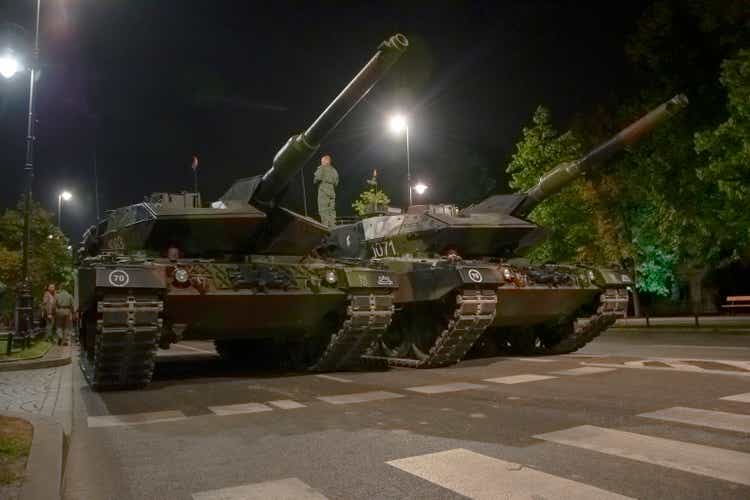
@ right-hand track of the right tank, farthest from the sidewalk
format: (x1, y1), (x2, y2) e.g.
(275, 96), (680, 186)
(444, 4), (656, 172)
(539, 288), (628, 355)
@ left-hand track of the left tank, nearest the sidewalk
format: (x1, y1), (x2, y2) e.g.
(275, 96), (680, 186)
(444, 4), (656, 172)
(81, 293), (164, 391)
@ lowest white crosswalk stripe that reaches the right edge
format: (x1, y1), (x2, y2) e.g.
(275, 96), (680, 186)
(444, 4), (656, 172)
(534, 425), (750, 486)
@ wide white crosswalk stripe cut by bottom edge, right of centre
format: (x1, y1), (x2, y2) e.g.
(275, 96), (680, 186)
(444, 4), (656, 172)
(386, 448), (629, 500)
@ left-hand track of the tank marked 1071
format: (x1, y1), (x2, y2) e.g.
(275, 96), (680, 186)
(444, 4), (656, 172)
(368, 289), (497, 368)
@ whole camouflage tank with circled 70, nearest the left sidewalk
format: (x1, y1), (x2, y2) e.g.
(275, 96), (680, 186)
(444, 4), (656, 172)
(76, 35), (408, 390)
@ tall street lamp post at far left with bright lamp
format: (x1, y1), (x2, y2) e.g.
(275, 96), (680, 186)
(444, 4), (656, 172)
(0, 0), (41, 353)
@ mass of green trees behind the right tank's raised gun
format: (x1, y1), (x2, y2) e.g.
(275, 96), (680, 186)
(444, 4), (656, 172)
(508, 0), (750, 296)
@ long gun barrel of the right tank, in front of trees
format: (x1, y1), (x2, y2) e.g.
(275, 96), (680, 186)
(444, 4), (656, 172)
(513, 94), (688, 217)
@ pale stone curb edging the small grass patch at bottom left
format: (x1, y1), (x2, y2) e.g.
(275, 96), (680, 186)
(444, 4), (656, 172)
(2, 411), (64, 500)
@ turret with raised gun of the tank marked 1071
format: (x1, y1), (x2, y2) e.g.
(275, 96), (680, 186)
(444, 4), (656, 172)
(324, 95), (688, 258)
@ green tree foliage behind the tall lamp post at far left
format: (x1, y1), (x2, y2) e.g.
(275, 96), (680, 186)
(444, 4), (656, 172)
(0, 203), (72, 313)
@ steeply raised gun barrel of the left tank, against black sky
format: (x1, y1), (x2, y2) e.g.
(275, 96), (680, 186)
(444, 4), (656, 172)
(251, 34), (409, 207)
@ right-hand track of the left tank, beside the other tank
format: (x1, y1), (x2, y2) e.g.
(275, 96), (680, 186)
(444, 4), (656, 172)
(310, 293), (395, 372)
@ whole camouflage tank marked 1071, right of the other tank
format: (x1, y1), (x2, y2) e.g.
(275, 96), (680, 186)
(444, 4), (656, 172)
(322, 95), (687, 367)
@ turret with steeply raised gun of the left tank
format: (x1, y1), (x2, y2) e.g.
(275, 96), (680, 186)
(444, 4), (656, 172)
(82, 34), (409, 258)
